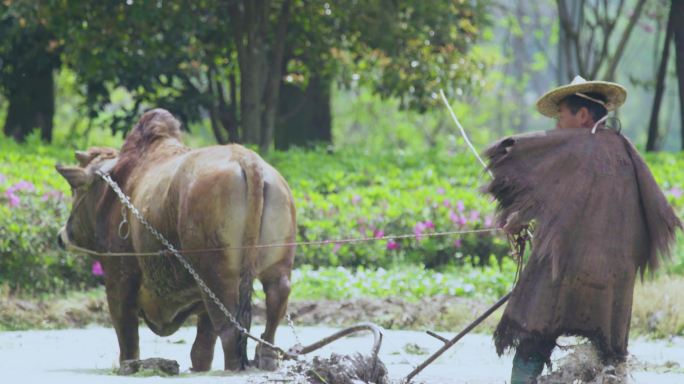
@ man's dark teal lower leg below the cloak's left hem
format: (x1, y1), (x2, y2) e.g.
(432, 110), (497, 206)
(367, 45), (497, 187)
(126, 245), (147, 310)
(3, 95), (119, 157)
(511, 340), (556, 384)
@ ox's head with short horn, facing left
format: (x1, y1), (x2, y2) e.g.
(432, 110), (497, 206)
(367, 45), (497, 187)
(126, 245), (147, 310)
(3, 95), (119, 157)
(55, 148), (118, 249)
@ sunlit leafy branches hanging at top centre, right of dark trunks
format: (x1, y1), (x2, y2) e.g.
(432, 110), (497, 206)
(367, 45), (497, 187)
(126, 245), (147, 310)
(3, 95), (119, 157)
(332, 0), (491, 112)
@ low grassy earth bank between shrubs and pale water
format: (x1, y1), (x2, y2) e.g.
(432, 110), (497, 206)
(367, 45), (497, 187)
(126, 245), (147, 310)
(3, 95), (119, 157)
(0, 267), (684, 338)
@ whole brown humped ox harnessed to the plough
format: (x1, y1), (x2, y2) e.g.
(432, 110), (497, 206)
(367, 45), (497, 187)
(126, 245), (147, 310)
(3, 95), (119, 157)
(57, 109), (295, 371)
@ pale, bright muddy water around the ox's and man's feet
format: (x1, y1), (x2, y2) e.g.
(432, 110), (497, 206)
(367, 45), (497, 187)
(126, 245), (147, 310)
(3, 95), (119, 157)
(0, 327), (684, 384)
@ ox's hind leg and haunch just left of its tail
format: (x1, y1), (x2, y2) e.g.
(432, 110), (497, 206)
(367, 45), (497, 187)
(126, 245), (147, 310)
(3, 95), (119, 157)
(178, 170), (256, 370)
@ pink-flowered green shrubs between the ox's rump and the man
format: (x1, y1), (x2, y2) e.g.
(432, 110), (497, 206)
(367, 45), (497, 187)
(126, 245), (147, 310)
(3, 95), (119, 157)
(268, 149), (508, 267)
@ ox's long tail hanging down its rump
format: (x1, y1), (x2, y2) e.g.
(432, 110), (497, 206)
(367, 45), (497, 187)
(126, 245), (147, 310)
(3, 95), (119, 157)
(236, 150), (264, 368)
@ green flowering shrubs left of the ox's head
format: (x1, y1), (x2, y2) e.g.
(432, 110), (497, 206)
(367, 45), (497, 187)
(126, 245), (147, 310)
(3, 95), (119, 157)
(0, 135), (97, 293)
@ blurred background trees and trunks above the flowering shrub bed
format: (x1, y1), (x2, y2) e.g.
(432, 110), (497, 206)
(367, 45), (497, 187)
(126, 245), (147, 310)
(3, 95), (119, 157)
(0, 0), (684, 151)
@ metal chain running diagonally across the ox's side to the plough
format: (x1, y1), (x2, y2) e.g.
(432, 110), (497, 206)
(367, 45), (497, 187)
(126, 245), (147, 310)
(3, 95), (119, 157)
(96, 170), (293, 358)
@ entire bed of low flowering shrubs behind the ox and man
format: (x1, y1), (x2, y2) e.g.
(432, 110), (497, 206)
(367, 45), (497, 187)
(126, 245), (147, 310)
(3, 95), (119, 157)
(0, 138), (684, 291)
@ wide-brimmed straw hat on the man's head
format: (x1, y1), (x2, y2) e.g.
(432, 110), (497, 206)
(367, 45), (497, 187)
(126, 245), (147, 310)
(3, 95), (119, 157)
(537, 76), (627, 117)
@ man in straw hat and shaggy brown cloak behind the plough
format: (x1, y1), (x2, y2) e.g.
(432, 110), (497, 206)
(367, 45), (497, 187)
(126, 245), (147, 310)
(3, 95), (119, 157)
(485, 76), (681, 384)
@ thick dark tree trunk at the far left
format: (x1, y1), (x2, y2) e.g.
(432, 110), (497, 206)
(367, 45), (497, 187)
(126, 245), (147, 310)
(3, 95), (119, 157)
(4, 65), (55, 143)
